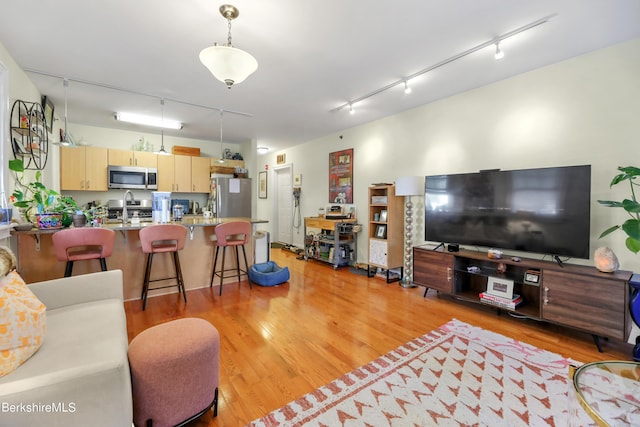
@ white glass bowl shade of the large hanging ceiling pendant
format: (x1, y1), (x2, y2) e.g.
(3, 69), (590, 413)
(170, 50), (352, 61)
(200, 46), (258, 87)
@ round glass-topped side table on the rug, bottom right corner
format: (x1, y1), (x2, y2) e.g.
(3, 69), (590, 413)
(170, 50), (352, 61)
(569, 360), (640, 427)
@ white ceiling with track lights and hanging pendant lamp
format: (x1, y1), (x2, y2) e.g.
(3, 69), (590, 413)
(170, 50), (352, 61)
(0, 0), (640, 150)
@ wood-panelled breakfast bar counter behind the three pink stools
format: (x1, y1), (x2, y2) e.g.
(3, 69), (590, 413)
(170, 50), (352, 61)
(12, 216), (267, 300)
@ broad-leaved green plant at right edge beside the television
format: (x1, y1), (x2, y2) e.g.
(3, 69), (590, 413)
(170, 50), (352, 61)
(598, 166), (640, 254)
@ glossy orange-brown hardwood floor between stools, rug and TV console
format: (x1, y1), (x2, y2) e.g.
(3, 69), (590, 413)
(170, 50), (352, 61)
(125, 249), (632, 427)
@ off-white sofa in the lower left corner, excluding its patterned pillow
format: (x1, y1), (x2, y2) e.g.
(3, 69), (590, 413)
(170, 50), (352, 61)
(0, 270), (133, 427)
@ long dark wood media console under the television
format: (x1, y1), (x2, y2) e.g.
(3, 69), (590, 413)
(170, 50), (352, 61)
(413, 246), (632, 351)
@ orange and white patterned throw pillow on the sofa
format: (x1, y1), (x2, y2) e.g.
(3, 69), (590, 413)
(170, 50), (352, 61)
(0, 271), (47, 377)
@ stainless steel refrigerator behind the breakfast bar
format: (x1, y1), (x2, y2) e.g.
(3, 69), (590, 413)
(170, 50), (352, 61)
(207, 176), (252, 218)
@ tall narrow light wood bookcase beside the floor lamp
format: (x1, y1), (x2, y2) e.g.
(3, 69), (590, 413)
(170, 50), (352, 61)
(369, 185), (404, 276)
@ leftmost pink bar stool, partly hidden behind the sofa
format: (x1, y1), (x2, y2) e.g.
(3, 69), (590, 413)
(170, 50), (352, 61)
(52, 228), (116, 277)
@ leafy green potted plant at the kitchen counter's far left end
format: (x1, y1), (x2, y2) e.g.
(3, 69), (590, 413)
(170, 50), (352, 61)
(9, 159), (62, 228)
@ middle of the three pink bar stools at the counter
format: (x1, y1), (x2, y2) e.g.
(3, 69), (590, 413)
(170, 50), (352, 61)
(140, 224), (187, 310)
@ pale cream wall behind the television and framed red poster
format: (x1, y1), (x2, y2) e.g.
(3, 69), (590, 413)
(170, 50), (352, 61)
(257, 40), (640, 271)
